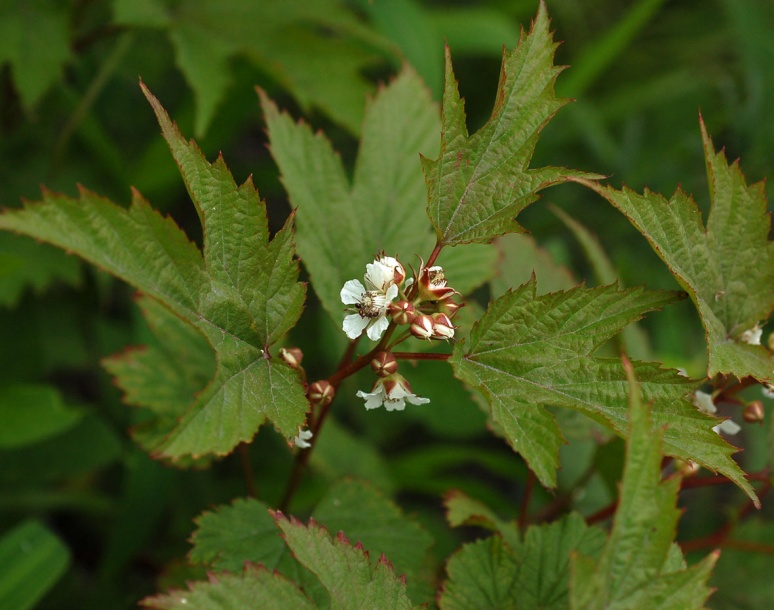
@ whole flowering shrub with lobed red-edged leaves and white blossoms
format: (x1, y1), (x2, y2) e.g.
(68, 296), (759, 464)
(0, 3), (774, 610)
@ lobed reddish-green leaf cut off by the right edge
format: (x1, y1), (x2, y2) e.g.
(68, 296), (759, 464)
(583, 122), (774, 381)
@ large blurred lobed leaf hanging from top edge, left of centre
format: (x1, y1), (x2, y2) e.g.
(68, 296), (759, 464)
(113, 0), (383, 137)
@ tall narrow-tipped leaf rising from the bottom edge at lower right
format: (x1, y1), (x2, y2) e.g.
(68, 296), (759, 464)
(570, 356), (717, 610)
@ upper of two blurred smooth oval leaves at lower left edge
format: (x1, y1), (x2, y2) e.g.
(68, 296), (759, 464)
(0, 385), (83, 449)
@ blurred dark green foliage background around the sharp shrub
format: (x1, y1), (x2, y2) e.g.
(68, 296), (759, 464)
(0, 0), (774, 609)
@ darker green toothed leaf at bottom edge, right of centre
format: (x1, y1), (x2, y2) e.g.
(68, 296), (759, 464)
(439, 514), (605, 610)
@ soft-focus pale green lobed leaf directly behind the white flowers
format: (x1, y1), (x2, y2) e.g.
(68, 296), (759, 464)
(261, 68), (440, 326)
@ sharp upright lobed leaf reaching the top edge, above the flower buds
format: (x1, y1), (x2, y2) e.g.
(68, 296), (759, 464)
(422, 3), (599, 245)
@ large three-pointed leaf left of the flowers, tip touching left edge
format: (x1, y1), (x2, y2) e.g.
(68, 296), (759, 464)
(0, 83), (307, 458)
